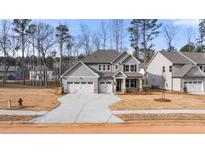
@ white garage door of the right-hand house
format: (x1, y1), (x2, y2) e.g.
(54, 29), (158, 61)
(184, 81), (203, 92)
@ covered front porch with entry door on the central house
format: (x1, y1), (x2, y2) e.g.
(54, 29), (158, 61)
(113, 73), (142, 93)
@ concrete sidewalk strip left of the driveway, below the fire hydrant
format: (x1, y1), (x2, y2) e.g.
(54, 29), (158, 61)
(0, 110), (48, 115)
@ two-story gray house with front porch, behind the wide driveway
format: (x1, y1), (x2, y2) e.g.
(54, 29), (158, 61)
(61, 50), (143, 93)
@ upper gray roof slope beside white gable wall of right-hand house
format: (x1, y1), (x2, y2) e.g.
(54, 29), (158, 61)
(160, 51), (193, 64)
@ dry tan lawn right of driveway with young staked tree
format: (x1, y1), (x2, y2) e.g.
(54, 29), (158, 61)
(110, 92), (205, 110)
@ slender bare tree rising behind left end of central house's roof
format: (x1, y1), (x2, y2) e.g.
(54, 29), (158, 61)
(79, 24), (92, 56)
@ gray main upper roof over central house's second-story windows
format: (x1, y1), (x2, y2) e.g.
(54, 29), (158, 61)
(82, 50), (121, 63)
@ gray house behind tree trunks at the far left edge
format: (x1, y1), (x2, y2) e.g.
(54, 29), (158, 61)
(0, 65), (22, 80)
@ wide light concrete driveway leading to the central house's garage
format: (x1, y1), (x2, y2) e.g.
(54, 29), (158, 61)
(30, 94), (123, 123)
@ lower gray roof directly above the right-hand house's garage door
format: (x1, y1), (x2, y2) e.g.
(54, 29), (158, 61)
(173, 64), (205, 78)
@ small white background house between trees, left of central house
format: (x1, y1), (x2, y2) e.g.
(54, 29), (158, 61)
(29, 66), (53, 80)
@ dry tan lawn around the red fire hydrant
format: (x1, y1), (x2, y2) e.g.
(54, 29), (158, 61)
(0, 88), (60, 111)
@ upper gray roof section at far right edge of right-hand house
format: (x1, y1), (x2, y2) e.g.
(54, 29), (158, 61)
(181, 52), (205, 64)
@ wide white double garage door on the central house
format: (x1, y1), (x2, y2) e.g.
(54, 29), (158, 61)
(68, 82), (94, 94)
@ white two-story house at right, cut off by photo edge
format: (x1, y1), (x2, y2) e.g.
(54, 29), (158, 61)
(147, 51), (205, 92)
